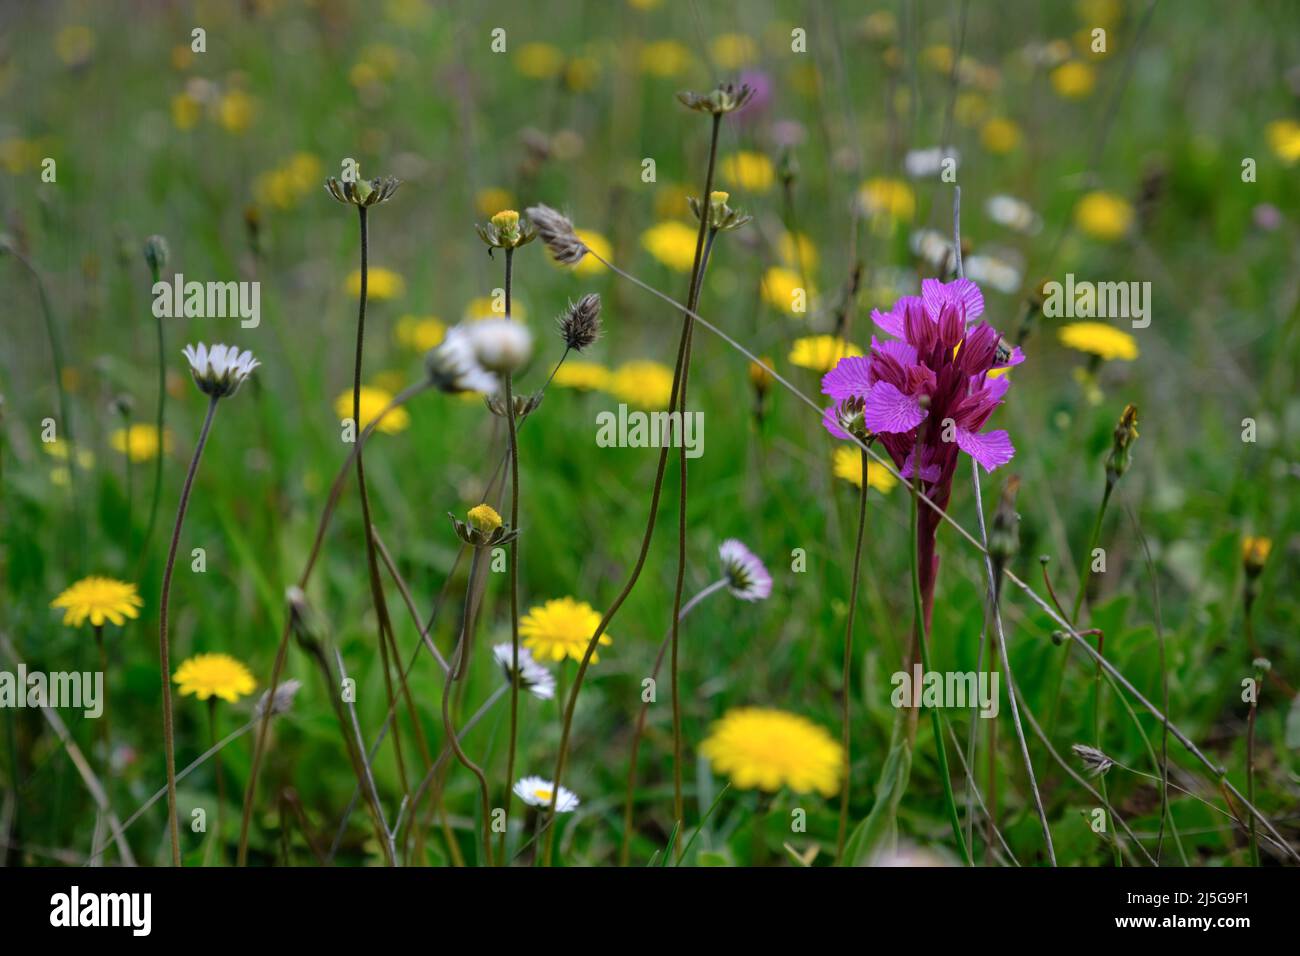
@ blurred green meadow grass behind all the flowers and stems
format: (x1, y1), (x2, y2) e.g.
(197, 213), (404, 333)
(0, 0), (1300, 865)
